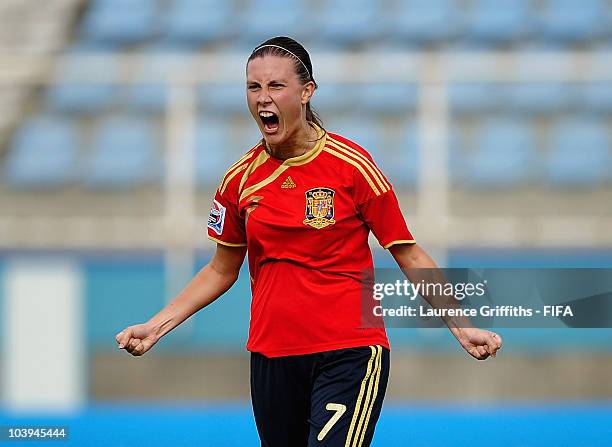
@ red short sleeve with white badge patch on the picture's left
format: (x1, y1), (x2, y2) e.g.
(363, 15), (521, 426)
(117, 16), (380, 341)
(207, 182), (247, 247)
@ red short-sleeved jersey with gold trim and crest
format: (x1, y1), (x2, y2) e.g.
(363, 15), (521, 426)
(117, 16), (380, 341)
(208, 124), (414, 357)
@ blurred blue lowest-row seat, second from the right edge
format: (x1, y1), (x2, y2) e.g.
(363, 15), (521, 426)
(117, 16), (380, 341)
(465, 118), (536, 188)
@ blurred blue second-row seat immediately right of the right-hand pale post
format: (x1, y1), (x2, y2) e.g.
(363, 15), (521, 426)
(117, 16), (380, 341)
(448, 82), (500, 114)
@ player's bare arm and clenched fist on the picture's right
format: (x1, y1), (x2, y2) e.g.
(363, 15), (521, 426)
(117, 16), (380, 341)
(389, 244), (502, 360)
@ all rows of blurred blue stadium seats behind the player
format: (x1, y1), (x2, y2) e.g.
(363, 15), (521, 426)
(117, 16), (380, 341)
(9, 0), (612, 195)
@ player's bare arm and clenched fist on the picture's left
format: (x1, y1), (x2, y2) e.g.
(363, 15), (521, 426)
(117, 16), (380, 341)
(115, 244), (246, 356)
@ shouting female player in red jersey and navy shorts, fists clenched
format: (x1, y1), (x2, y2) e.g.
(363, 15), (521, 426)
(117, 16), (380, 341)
(117, 37), (502, 447)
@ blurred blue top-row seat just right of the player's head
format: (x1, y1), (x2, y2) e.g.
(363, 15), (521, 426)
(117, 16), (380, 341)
(317, 0), (383, 46)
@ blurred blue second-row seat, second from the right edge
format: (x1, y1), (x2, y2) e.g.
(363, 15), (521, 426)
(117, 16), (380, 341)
(501, 82), (576, 115)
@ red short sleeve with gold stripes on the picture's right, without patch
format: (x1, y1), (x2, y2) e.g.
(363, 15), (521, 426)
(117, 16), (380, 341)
(353, 166), (415, 249)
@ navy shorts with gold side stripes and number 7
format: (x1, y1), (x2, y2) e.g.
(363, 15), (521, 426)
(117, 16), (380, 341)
(251, 345), (389, 447)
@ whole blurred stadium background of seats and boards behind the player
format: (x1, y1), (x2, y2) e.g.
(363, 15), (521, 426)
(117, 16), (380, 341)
(0, 0), (612, 446)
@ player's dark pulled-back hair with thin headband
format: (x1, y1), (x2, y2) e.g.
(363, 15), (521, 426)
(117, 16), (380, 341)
(247, 36), (323, 128)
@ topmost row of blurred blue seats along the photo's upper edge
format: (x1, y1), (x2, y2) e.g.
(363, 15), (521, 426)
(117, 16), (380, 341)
(68, 0), (611, 48)
